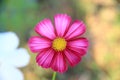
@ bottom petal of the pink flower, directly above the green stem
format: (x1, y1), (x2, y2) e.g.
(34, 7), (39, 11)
(51, 53), (68, 73)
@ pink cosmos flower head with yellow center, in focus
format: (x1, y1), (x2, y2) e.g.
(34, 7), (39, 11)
(29, 14), (88, 73)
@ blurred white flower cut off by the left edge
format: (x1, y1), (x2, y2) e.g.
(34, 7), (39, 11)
(0, 32), (30, 80)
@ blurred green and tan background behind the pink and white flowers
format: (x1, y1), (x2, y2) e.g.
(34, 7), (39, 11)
(0, 0), (120, 80)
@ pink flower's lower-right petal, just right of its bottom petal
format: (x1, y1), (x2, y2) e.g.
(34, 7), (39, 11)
(64, 50), (81, 66)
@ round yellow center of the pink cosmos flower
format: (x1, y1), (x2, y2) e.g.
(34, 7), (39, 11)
(52, 37), (67, 51)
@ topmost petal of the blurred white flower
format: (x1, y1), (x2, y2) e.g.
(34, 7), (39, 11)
(0, 32), (19, 54)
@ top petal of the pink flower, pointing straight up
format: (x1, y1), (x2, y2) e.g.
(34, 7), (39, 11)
(54, 14), (71, 37)
